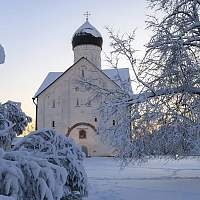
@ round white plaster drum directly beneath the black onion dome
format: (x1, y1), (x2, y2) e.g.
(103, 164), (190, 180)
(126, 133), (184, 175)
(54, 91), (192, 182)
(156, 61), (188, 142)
(73, 45), (101, 69)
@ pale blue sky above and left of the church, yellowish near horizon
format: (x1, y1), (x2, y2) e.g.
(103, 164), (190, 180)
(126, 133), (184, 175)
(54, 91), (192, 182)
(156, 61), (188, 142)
(0, 0), (148, 117)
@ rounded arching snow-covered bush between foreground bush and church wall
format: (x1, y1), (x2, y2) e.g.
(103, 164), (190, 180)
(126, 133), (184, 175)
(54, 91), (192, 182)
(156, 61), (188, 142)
(14, 129), (87, 199)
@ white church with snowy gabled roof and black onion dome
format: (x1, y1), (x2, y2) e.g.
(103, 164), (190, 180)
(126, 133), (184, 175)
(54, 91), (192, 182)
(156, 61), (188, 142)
(33, 19), (130, 156)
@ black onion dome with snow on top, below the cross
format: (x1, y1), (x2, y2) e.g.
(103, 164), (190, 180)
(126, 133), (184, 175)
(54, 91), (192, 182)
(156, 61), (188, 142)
(72, 21), (103, 48)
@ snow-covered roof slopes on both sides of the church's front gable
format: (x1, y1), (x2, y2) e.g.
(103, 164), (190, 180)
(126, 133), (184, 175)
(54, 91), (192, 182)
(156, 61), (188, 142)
(33, 68), (132, 98)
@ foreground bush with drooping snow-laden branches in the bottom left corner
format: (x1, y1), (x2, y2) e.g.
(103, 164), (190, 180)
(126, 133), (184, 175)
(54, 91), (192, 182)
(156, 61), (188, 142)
(0, 150), (69, 200)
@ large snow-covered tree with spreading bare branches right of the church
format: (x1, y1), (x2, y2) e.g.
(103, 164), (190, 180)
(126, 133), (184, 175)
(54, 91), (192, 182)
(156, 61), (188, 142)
(96, 0), (200, 160)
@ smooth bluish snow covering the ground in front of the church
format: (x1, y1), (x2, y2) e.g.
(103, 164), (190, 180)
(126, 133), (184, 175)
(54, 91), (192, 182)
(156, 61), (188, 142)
(84, 158), (200, 200)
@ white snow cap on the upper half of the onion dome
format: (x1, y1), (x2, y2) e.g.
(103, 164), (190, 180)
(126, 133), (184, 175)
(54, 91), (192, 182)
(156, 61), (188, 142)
(73, 21), (102, 37)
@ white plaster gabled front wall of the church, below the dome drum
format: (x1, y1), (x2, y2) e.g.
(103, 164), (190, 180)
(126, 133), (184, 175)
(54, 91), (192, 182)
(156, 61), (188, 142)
(37, 59), (121, 156)
